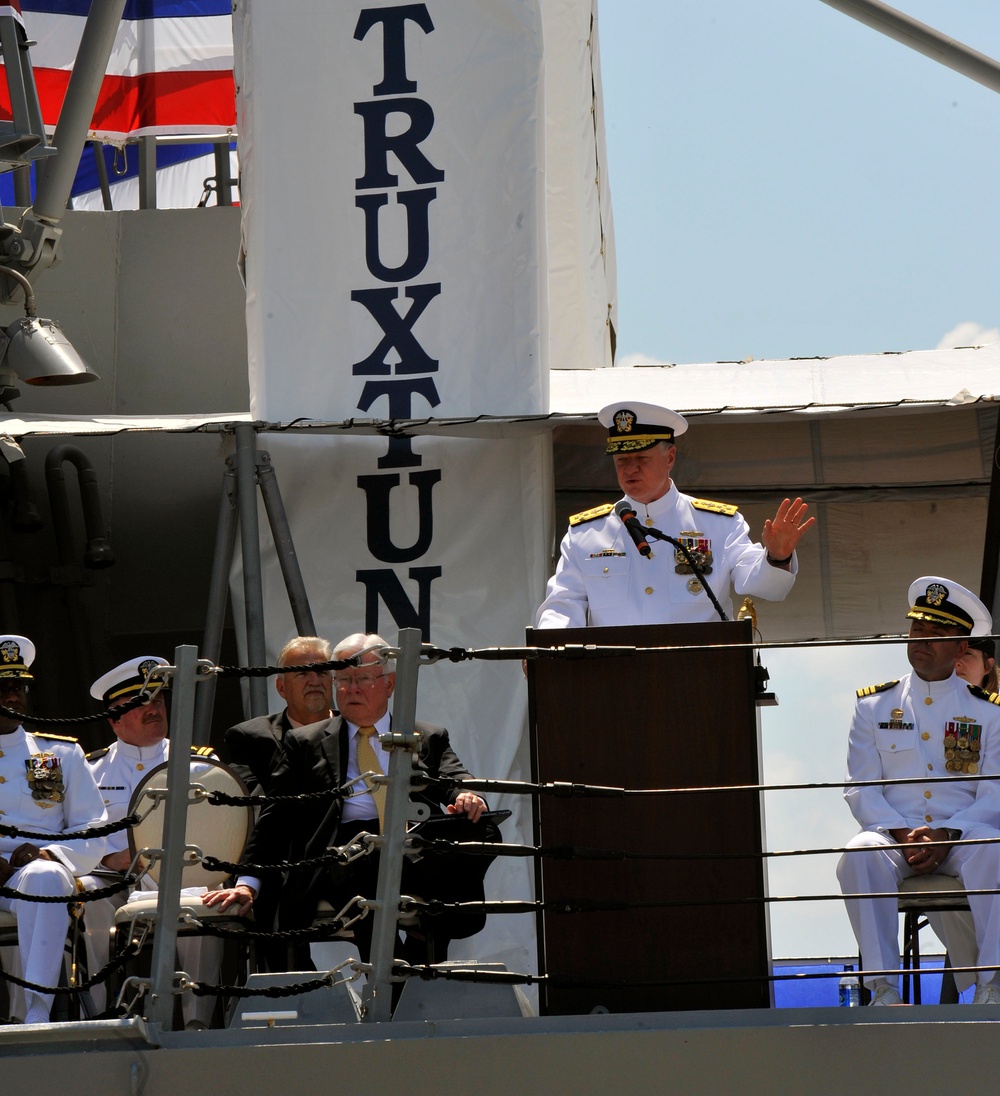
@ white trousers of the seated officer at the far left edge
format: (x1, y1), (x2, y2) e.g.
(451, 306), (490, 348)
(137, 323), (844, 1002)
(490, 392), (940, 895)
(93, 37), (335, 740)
(0, 859), (77, 1024)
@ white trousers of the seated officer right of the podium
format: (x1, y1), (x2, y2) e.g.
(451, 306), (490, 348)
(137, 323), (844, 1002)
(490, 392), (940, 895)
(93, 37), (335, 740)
(837, 825), (1000, 986)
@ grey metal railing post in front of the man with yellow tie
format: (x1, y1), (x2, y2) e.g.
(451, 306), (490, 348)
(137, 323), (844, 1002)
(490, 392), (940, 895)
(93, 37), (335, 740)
(362, 628), (421, 1023)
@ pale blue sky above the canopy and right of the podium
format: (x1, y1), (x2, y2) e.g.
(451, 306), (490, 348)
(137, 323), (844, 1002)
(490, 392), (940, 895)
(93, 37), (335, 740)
(600, 0), (1000, 956)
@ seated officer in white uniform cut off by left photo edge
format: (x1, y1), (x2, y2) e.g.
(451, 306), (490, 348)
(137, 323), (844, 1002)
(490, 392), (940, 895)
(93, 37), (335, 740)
(0, 636), (107, 1024)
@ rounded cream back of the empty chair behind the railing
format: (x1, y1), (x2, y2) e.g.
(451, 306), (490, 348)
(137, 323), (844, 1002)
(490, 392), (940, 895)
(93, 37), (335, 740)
(128, 757), (253, 888)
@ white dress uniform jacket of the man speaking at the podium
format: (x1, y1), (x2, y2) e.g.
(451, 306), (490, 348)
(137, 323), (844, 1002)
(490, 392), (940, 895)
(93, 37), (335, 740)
(535, 483), (798, 628)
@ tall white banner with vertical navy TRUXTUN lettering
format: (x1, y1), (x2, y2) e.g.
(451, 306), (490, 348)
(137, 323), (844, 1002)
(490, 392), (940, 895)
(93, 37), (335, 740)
(234, 0), (613, 969)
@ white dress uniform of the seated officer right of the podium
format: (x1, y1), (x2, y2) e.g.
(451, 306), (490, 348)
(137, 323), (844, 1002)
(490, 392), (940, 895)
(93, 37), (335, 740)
(837, 673), (1000, 984)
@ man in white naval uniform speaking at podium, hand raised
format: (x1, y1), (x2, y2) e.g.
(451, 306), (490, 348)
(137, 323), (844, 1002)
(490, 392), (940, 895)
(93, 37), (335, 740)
(535, 401), (816, 628)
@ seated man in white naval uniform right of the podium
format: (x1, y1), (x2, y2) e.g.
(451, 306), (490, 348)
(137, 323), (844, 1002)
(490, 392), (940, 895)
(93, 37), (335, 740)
(837, 575), (1000, 1005)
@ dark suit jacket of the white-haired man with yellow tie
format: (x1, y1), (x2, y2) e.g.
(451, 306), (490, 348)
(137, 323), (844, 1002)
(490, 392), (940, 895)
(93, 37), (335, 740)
(243, 716), (482, 928)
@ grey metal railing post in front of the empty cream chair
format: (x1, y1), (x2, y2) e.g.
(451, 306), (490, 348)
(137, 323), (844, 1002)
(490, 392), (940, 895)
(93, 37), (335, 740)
(149, 646), (197, 1031)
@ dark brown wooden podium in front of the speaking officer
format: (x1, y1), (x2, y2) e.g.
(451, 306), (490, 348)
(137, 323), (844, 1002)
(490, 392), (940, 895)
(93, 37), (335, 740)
(527, 620), (773, 1015)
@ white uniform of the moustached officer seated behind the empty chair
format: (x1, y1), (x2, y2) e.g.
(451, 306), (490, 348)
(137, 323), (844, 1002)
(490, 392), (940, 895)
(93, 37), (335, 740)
(87, 739), (223, 1027)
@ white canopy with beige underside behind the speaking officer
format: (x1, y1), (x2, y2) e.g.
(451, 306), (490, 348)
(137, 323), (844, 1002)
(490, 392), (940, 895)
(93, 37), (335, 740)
(0, 345), (1000, 640)
